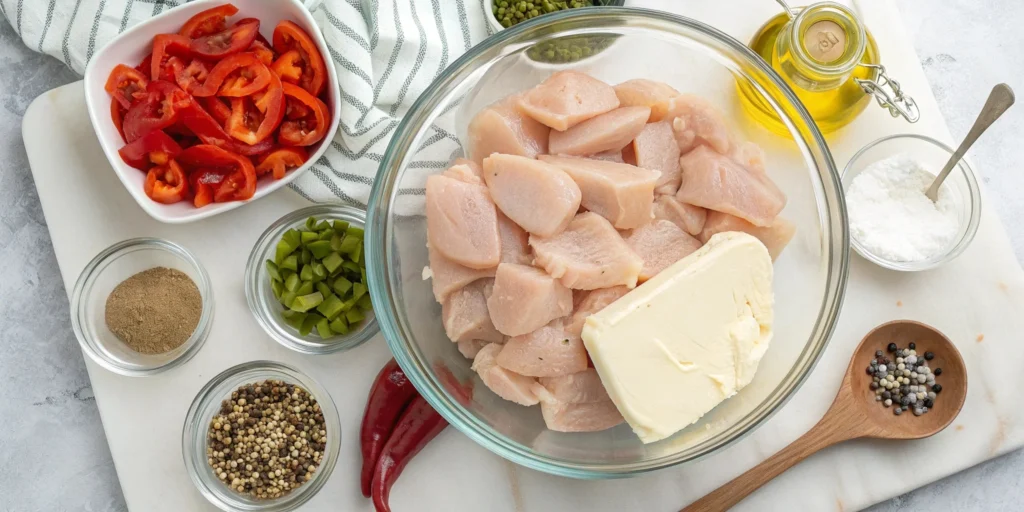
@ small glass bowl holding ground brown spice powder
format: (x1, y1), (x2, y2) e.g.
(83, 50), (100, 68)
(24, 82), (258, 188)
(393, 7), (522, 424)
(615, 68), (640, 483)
(71, 238), (213, 377)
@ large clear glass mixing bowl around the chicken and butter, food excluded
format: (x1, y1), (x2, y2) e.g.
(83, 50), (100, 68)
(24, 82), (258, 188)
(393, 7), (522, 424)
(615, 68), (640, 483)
(367, 7), (850, 478)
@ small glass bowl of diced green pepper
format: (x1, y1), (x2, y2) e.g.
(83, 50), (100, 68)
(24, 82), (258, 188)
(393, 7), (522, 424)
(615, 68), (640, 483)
(246, 205), (378, 354)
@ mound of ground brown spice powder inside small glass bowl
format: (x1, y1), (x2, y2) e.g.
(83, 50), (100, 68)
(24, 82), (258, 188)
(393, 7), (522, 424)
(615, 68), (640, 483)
(105, 266), (203, 354)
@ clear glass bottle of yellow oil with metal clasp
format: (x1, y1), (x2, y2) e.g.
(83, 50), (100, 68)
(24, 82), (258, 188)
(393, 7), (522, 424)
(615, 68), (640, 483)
(738, 2), (920, 136)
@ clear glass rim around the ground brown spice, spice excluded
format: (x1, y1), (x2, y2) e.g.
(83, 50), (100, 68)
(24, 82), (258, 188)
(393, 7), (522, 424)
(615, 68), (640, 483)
(70, 237), (214, 377)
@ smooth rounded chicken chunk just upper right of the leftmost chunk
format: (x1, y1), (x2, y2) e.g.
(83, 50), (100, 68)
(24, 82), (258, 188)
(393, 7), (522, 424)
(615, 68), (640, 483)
(483, 155), (583, 237)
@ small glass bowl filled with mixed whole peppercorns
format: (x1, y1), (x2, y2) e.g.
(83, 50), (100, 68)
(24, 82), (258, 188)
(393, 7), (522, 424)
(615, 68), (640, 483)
(181, 360), (341, 512)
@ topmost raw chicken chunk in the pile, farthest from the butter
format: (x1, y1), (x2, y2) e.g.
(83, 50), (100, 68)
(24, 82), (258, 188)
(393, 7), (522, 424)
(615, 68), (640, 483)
(518, 71), (618, 131)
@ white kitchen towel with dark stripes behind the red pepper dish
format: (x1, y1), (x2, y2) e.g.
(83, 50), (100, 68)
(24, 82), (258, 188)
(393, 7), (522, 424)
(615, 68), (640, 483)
(0, 0), (487, 208)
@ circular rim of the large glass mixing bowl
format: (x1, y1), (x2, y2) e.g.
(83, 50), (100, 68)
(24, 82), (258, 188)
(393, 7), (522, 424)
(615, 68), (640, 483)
(367, 6), (850, 479)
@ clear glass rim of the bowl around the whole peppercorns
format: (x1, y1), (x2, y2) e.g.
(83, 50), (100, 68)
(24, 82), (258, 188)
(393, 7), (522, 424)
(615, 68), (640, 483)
(181, 360), (344, 512)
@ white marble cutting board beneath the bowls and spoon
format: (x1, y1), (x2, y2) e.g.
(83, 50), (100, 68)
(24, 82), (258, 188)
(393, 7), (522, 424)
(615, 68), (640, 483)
(24, 0), (1024, 512)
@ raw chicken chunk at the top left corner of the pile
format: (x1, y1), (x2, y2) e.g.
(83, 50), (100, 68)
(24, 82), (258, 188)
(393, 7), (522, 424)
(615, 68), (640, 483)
(467, 95), (551, 163)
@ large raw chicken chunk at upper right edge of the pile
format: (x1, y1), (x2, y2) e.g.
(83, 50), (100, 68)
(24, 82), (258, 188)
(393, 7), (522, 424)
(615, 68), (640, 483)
(676, 145), (785, 226)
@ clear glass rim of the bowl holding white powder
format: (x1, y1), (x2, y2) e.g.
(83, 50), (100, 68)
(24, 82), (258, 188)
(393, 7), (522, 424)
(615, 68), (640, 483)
(842, 133), (981, 272)
